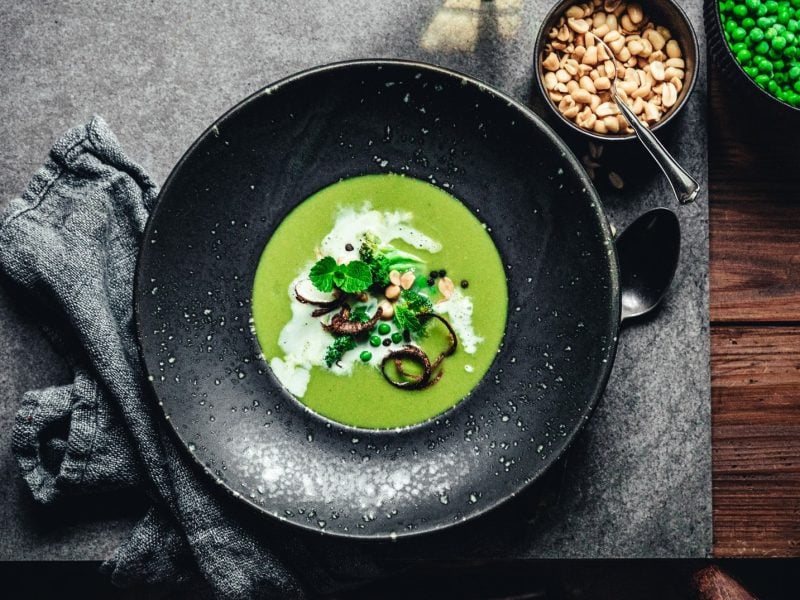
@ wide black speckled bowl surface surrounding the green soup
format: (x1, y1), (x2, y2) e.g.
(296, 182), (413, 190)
(135, 60), (620, 539)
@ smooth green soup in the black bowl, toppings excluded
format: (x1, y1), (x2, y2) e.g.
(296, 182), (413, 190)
(252, 174), (508, 429)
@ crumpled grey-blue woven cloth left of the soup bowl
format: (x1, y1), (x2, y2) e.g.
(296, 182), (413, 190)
(0, 117), (354, 598)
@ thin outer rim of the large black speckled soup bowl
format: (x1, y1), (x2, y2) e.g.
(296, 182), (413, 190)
(132, 58), (622, 542)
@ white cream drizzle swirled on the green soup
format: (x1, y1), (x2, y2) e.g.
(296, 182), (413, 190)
(269, 202), (483, 398)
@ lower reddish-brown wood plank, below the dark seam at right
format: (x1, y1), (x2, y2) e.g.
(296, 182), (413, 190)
(711, 327), (800, 557)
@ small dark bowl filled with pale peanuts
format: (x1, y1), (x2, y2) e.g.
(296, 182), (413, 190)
(534, 0), (698, 141)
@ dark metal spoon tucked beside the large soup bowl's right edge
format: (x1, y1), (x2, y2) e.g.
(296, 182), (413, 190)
(615, 208), (681, 321)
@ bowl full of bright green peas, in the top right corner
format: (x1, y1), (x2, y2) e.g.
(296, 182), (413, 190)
(705, 0), (800, 116)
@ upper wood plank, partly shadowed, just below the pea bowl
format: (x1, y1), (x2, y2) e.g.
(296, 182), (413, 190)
(709, 69), (800, 322)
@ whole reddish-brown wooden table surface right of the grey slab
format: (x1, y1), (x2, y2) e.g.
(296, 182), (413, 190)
(709, 67), (800, 557)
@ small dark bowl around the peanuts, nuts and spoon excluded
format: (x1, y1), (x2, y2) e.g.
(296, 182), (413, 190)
(533, 0), (699, 142)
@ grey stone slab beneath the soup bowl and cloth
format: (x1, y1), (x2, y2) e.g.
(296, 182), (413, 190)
(0, 0), (711, 559)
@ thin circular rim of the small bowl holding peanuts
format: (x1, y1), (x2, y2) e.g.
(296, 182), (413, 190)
(533, 0), (700, 142)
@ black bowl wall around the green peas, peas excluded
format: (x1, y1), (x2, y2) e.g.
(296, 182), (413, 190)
(703, 0), (800, 123)
